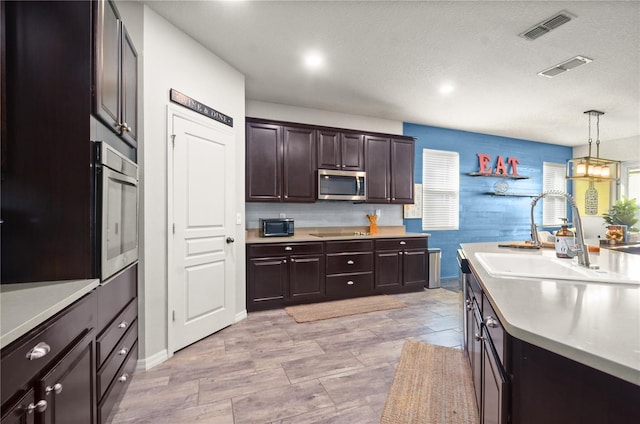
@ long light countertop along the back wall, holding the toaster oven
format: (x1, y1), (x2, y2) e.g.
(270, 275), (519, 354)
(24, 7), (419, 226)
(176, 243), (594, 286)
(246, 225), (431, 244)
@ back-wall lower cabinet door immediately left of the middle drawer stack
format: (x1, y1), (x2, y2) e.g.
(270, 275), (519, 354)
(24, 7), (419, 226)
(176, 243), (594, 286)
(289, 255), (325, 302)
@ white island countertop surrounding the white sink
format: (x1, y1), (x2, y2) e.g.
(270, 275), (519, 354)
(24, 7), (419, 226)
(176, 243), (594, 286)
(461, 243), (640, 385)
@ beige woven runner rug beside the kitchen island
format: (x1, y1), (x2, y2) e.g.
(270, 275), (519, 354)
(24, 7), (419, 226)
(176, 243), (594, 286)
(380, 340), (480, 424)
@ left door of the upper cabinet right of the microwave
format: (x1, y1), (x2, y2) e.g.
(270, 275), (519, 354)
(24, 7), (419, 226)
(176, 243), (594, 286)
(364, 135), (391, 203)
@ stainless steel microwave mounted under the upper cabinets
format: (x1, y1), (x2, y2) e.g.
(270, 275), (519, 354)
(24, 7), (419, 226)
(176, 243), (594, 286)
(318, 169), (367, 200)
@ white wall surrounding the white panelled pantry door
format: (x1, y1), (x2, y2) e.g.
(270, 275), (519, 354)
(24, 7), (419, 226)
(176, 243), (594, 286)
(139, 6), (246, 368)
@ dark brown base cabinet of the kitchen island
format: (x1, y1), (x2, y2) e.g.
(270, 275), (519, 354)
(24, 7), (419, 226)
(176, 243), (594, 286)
(464, 274), (640, 424)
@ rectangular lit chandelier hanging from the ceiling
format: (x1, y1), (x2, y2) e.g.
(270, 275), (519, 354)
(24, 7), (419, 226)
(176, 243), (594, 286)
(566, 110), (620, 182)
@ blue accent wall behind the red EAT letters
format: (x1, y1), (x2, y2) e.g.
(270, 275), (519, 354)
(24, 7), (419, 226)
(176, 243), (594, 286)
(403, 123), (572, 278)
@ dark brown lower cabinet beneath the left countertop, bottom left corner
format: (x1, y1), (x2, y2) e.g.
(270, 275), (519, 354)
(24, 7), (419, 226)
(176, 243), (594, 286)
(0, 291), (97, 424)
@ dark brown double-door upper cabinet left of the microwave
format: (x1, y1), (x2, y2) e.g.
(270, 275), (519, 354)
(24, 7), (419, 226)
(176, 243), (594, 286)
(246, 119), (316, 203)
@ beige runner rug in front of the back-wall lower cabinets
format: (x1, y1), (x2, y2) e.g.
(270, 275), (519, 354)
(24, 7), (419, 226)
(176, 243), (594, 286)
(284, 295), (407, 322)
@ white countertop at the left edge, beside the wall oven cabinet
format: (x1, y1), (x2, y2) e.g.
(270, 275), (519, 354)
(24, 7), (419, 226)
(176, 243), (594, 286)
(0, 279), (100, 347)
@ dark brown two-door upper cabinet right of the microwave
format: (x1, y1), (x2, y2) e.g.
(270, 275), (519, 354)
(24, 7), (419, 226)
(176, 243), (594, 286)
(364, 135), (415, 204)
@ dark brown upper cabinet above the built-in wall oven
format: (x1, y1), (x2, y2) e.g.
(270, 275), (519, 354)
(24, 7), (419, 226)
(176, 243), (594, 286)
(94, 0), (138, 147)
